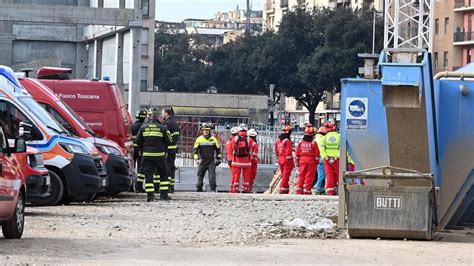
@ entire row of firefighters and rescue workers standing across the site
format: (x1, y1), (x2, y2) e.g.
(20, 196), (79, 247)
(132, 107), (344, 202)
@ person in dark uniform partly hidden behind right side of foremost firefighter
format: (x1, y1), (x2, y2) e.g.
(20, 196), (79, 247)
(161, 107), (179, 193)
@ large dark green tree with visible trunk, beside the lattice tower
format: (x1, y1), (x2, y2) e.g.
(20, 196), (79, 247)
(279, 8), (382, 123)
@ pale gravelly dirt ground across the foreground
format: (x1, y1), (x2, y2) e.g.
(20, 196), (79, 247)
(0, 192), (474, 265)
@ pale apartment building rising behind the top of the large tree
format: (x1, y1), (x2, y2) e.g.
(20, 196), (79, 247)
(263, 0), (384, 30)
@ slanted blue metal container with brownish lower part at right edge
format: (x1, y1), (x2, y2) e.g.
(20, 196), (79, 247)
(435, 79), (474, 228)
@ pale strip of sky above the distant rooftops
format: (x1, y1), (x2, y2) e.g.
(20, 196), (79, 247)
(155, 0), (263, 22)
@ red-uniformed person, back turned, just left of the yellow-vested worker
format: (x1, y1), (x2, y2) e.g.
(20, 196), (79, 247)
(295, 124), (319, 195)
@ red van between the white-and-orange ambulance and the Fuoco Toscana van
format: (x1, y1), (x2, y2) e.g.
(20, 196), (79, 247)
(19, 77), (133, 196)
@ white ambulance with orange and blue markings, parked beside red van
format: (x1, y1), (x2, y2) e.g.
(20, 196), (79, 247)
(0, 66), (108, 206)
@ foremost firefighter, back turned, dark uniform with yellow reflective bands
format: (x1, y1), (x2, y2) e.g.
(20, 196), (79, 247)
(137, 108), (172, 202)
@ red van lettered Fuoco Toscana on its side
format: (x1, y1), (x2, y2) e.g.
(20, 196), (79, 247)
(37, 67), (133, 158)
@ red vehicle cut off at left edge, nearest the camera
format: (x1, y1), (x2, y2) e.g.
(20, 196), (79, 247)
(0, 125), (26, 239)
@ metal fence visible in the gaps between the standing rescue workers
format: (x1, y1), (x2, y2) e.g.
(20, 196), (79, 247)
(176, 122), (302, 166)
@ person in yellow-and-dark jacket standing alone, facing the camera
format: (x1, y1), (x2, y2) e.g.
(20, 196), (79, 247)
(194, 124), (222, 192)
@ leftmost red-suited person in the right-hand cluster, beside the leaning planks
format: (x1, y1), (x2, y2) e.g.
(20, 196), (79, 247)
(275, 125), (295, 194)
